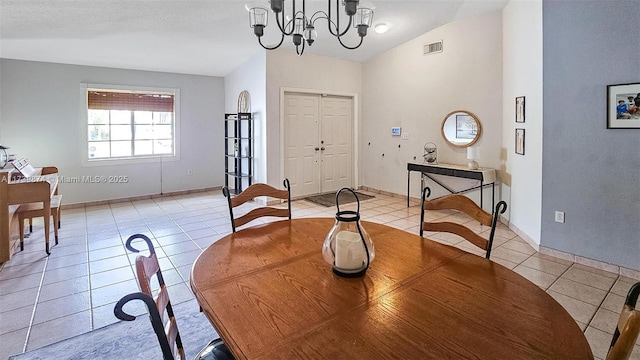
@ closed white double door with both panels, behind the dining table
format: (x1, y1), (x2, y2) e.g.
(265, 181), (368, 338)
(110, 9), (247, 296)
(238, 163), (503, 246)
(283, 93), (354, 197)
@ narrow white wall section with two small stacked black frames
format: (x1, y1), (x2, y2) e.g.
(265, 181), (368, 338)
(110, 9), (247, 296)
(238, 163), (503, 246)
(501, 0), (542, 245)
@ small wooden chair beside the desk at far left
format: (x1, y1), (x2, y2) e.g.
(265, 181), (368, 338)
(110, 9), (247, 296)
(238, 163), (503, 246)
(17, 166), (62, 254)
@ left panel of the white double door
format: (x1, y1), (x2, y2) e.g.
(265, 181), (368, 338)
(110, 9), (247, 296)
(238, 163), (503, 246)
(283, 94), (320, 197)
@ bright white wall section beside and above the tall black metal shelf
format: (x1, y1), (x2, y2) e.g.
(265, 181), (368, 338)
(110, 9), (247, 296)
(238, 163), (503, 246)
(225, 51), (267, 182)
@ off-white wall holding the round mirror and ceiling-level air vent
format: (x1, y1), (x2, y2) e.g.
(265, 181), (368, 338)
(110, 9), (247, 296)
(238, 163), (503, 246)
(361, 12), (502, 208)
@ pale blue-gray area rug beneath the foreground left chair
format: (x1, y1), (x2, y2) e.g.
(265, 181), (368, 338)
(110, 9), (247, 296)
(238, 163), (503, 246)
(9, 300), (218, 360)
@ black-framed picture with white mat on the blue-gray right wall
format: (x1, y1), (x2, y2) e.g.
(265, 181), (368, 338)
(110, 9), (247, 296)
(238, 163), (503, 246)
(607, 83), (640, 129)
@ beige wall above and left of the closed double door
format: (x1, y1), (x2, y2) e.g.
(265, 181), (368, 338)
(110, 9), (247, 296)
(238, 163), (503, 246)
(266, 49), (362, 185)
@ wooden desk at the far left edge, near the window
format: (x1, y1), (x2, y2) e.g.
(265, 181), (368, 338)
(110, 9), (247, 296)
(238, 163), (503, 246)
(0, 172), (58, 263)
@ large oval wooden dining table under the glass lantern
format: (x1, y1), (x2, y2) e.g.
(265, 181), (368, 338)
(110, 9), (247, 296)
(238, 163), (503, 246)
(191, 218), (593, 360)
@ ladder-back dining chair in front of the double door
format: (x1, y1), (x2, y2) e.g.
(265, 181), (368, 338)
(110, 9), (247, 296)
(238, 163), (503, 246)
(222, 179), (291, 232)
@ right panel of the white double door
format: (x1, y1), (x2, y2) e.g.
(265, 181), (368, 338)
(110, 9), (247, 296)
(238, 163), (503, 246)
(320, 96), (353, 193)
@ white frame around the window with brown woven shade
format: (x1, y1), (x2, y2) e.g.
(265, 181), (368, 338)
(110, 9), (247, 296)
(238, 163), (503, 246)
(80, 83), (180, 166)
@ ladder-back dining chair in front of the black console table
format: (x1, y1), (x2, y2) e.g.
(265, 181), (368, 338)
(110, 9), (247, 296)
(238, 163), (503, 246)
(420, 187), (507, 259)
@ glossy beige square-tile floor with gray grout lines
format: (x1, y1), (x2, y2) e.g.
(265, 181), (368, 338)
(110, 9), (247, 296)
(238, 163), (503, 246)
(0, 191), (640, 360)
